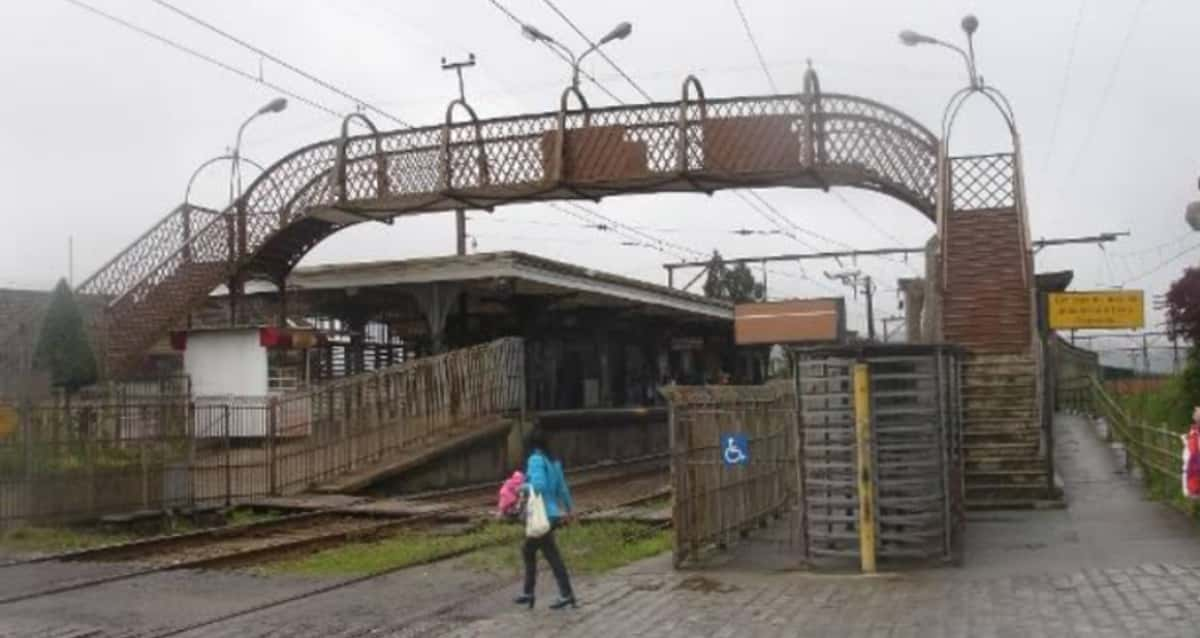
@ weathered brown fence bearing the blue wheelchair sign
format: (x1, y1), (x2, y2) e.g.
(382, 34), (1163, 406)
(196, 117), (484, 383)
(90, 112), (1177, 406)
(664, 384), (796, 566)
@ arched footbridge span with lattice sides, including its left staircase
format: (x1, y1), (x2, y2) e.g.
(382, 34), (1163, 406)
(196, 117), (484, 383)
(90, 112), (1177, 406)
(65, 83), (937, 374)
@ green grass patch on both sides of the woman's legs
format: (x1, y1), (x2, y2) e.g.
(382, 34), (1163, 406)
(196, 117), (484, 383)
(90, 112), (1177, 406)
(468, 520), (671, 573)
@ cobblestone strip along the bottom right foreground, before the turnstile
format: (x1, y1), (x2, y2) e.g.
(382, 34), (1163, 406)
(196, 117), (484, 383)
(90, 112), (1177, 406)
(451, 565), (1200, 638)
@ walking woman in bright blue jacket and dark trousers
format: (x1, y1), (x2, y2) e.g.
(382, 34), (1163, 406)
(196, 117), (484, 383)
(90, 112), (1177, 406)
(515, 427), (575, 609)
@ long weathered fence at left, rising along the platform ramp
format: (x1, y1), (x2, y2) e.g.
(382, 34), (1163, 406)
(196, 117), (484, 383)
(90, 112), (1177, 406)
(0, 338), (524, 528)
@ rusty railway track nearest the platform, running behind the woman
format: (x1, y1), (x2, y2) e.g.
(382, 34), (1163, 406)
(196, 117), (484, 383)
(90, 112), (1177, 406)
(0, 464), (664, 606)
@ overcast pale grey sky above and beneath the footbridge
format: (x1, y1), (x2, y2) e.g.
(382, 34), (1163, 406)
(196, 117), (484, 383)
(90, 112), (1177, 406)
(0, 0), (1200, 362)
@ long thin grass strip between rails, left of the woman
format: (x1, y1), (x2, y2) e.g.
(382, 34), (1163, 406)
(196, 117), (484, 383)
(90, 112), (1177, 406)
(260, 523), (522, 576)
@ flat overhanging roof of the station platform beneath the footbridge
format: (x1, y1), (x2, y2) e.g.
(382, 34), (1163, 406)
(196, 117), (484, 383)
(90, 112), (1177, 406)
(255, 252), (733, 321)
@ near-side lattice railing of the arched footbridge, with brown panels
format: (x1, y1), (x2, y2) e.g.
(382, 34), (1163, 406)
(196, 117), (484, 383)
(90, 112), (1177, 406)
(98, 94), (937, 305)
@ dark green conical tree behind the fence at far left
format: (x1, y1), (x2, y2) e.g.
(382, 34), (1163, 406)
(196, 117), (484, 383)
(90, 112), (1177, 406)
(34, 279), (97, 396)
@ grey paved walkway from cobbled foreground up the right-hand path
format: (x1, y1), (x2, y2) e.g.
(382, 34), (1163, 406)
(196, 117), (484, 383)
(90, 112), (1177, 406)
(452, 416), (1200, 638)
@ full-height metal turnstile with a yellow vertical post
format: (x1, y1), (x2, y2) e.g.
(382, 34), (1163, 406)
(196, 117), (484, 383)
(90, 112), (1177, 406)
(796, 345), (962, 570)
